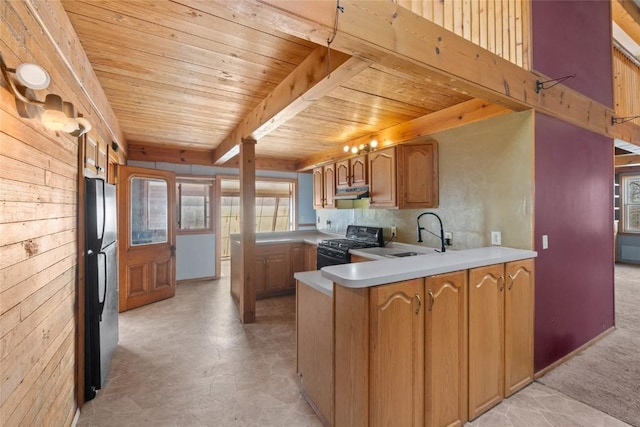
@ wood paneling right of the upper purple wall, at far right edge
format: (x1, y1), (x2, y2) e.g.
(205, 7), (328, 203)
(613, 47), (640, 126)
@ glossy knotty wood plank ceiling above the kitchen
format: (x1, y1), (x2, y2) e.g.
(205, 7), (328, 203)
(62, 0), (470, 164)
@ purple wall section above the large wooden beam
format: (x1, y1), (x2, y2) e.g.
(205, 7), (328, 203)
(531, 0), (613, 107)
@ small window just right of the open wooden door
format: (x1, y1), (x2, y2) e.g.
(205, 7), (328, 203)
(176, 178), (213, 232)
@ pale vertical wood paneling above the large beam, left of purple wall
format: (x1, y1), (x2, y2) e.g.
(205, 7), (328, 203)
(397, 0), (531, 70)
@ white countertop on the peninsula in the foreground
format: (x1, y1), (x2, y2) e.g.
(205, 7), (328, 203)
(322, 246), (538, 288)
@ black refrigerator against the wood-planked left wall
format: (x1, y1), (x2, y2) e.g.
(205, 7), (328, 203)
(84, 178), (118, 400)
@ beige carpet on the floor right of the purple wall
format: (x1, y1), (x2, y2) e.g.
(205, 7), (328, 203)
(538, 265), (640, 427)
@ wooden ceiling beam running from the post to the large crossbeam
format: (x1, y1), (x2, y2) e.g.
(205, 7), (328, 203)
(211, 46), (370, 164)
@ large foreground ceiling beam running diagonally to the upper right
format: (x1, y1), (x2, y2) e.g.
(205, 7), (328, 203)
(239, 0), (632, 145)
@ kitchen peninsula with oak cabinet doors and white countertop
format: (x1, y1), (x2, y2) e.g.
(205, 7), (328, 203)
(295, 246), (537, 427)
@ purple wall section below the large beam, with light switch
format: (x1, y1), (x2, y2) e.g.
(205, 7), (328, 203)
(534, 113), (614, 371)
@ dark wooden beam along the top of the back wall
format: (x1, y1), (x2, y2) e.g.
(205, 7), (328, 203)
(128, 141), (297, 172)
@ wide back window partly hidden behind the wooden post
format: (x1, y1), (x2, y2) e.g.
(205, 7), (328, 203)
(220, 179), (295, 258)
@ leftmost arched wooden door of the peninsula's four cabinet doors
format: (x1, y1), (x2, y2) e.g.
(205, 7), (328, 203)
(369, 279), (424, 427)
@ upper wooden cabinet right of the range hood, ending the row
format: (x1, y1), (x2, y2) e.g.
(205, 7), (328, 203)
(369, 141), (438, 209)
